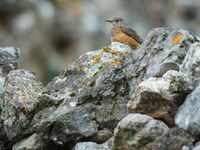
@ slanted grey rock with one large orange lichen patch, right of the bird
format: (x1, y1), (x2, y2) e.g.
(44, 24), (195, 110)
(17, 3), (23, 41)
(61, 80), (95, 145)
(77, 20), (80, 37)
(123, 28), (198, 96)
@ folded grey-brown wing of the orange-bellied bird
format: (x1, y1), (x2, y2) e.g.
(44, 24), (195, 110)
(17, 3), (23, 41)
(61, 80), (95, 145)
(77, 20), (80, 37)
(121, 26), (143, 44)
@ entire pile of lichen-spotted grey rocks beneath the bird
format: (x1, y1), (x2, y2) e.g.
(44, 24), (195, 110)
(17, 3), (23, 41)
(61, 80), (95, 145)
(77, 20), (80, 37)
(0, 28), (200, 150)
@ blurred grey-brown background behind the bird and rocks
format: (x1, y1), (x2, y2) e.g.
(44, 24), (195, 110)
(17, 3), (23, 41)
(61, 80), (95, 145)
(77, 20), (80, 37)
(0, 0), (200, 84)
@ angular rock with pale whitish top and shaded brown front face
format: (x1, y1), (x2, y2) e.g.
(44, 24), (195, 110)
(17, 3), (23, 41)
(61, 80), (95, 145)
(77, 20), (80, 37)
(127, 70), (185, 126)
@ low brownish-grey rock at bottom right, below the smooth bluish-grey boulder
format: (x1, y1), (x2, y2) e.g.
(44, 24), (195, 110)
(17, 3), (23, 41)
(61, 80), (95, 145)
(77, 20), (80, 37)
(152, 128), (194, 150)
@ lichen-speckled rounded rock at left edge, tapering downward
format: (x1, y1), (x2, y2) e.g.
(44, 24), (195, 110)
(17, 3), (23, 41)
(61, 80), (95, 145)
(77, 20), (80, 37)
(0, 70), (42, 141)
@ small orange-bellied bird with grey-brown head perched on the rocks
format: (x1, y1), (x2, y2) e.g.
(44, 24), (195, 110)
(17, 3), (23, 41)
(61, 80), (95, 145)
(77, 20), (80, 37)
(105, 17), (143, 50)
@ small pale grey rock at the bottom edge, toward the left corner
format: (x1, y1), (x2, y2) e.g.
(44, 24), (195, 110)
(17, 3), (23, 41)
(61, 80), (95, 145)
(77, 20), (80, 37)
(12, 133), (45, 150)
